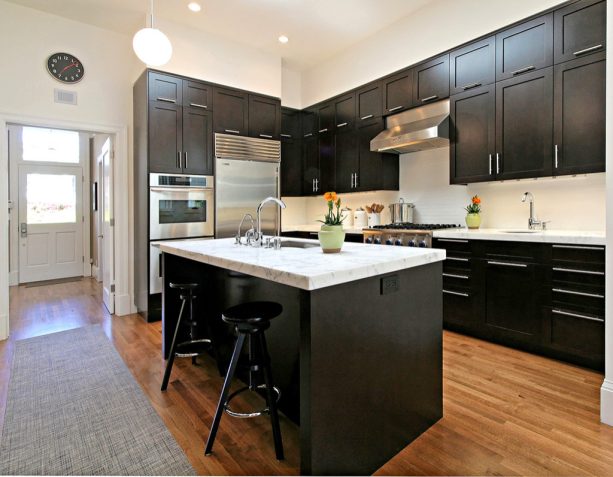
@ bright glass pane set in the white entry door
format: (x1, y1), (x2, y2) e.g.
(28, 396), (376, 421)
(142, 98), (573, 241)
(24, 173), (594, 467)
(26, 174), (77, 224)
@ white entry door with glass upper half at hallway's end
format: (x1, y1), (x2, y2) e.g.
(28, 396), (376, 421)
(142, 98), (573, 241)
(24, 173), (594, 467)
(19, 164), (83, 283)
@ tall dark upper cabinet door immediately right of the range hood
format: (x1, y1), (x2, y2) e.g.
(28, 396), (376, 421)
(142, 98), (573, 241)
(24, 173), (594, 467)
(449, 84), (496, 184)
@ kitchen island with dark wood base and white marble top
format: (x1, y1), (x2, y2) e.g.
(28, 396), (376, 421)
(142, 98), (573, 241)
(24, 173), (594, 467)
(160, 239), (445, 475)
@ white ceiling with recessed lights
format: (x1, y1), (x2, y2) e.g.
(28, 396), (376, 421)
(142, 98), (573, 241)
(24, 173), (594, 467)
(7, 0), (437, 71)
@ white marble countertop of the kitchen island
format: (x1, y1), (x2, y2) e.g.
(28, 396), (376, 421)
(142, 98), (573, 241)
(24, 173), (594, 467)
(160, 238), (445, 290)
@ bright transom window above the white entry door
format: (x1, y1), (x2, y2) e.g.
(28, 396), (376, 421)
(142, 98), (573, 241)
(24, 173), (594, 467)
(22, 127), (79, 164)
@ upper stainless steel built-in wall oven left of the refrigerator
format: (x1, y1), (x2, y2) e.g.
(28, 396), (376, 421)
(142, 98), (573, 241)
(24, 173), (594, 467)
(149, 174), (215, 240)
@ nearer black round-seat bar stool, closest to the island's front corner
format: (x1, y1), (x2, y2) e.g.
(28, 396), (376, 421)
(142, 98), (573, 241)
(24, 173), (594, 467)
(204, 301), (284, 460)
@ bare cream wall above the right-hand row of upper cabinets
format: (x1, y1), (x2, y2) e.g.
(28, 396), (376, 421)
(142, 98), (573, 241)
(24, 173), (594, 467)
(302, 0), (562, 106)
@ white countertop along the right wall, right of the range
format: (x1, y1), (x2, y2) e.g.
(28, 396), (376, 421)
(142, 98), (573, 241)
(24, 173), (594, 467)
(434, 228), (606, 245)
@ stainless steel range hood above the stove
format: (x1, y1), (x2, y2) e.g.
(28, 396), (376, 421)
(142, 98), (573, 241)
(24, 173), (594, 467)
(370, 99), (449, 154)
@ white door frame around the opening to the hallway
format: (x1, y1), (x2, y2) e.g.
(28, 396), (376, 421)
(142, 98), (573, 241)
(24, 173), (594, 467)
(0, 112), (131, 340)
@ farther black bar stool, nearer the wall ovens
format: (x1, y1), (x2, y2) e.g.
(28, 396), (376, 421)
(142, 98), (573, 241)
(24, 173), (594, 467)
(162, 283), (212, 391)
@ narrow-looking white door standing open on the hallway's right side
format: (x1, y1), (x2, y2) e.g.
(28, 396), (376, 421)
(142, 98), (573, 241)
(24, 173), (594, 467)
(101, 139), (115, 314)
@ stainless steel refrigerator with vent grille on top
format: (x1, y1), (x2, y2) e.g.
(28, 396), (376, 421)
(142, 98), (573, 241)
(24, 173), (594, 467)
(215, 134), (281, 238)
